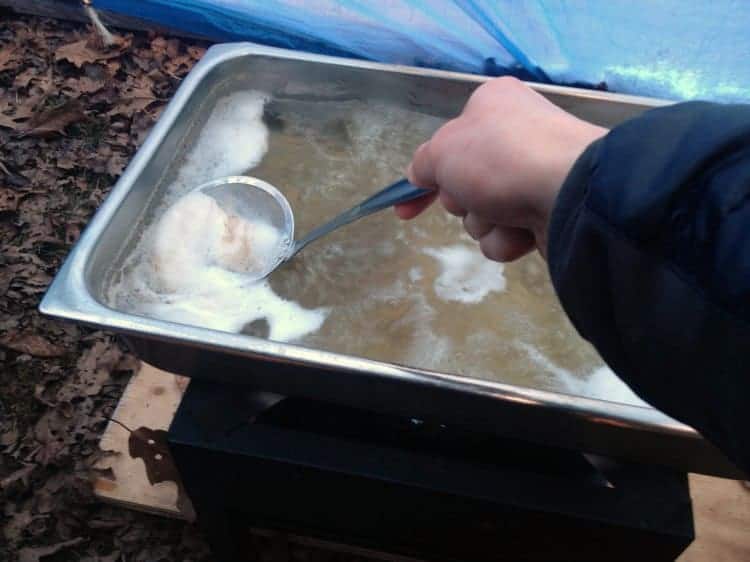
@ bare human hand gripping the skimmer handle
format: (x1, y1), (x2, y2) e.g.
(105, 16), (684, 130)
(396, 77), (607, 261)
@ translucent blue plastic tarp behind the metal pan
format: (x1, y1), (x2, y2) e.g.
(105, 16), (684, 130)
(100, 0), (750, 102)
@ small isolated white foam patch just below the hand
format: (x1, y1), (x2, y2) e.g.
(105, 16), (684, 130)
(424, 244), (505, 304)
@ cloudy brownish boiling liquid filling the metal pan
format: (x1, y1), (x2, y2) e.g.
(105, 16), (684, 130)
(110, 92), (648, 403)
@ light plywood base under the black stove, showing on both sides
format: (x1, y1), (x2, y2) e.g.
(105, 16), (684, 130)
(94, 365), (750, 562)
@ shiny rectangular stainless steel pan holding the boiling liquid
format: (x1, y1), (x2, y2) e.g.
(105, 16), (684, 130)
(40, 43), (738, 476)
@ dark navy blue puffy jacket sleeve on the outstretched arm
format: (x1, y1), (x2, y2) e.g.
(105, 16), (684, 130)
(548, 103), (750, 473)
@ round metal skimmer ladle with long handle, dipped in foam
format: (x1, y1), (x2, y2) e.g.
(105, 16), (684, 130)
(194, 176), (431, 279)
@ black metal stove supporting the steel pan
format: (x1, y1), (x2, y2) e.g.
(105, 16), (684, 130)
(170, 380), (693, 562)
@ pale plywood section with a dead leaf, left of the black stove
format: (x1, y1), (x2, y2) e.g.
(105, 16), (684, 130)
(94, 364), (193, 519)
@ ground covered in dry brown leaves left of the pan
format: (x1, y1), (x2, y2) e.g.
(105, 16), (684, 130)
(0, 12), (213, 562)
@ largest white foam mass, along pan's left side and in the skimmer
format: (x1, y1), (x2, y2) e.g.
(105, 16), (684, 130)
(112, 92), (327, 341)
